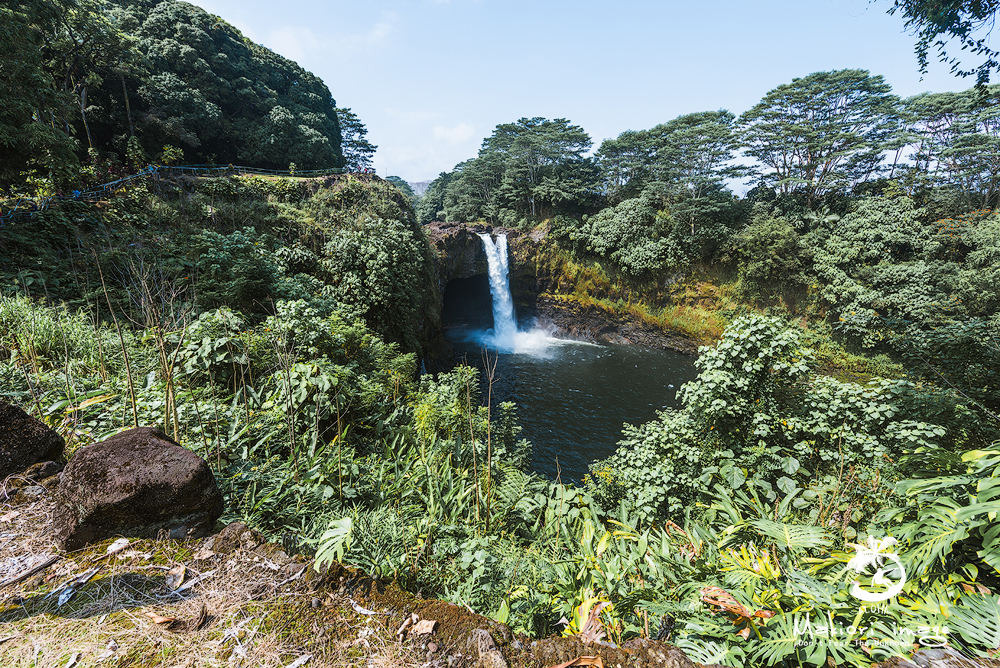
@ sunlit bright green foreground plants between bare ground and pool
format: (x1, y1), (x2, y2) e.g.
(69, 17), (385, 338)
(0, 296), (1000, 667)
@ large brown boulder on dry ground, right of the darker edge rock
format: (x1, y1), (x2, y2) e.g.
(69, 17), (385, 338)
(52, 427), (223, 550)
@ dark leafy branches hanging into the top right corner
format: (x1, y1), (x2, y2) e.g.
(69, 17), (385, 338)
(889, 0), (1000, 87)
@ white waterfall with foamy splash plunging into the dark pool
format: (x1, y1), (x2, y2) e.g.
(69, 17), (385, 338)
(476, 234), (563, 355)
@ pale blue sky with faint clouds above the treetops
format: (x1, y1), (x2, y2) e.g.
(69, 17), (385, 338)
(195, 0), (974, 181)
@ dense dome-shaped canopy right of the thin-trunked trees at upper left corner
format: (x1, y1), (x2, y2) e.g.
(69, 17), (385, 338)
(116, 0), (341, 168)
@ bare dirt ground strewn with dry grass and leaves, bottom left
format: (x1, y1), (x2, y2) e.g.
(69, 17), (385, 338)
(0, 486), (716, 668)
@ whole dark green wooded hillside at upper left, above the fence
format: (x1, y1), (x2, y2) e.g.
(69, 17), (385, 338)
(0, 0), (350, 186)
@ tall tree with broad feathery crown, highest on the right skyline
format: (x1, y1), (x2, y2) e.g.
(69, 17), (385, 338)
(740, 70), (902, 207)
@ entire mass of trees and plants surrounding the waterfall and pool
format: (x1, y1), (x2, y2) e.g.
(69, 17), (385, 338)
(0, 0), (1000, 667)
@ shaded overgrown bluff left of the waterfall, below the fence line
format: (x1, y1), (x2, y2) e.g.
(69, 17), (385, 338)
(0, 176), (440, 351)
